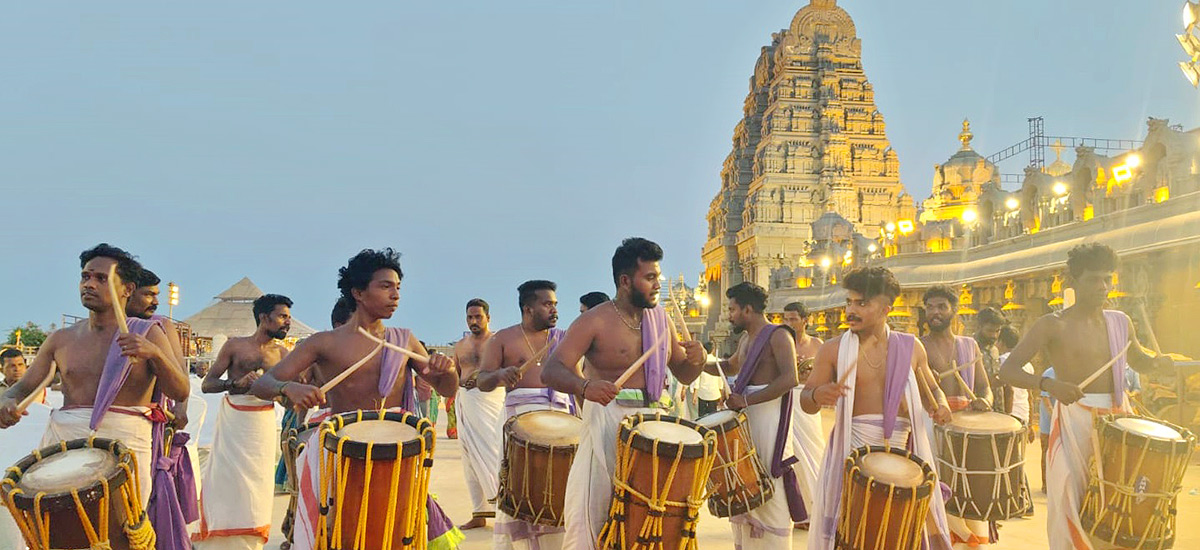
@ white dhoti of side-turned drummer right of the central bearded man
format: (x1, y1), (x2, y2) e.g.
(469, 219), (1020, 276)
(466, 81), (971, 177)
(730, 385), (792, 550)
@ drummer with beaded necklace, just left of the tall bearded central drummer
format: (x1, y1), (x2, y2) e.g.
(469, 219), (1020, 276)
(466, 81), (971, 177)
(479, 281), (575, 549)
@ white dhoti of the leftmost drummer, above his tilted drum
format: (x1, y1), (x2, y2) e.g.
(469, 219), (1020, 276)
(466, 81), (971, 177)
(38, 407), (154, 509)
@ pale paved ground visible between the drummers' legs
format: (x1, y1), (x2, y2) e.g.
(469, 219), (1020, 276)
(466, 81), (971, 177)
(268, 410), (1200, 550)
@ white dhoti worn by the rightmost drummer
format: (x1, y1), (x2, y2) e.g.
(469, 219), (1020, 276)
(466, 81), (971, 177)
(1046, 394), (1116, 550)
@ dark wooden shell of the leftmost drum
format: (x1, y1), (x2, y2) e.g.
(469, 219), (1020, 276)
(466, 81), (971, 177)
(6, 437), (138, 550)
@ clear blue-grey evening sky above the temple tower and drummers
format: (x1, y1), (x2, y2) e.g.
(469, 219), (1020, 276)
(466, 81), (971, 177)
(0, 0), (1200, 343)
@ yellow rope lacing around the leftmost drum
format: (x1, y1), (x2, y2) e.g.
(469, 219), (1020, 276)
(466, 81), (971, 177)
(0, 432), (156, 550)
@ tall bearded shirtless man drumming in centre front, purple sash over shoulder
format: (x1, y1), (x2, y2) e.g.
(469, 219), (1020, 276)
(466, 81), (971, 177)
(541, 238), (707, 550)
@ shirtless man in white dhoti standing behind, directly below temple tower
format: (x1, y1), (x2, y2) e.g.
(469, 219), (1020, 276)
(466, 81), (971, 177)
(784, 301), (829, 530)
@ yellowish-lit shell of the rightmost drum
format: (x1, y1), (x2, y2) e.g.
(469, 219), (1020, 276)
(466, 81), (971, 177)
(1080, 414), (1196, 549)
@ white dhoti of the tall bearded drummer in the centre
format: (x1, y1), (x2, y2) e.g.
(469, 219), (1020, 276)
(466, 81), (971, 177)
(563, 400), (656, 550)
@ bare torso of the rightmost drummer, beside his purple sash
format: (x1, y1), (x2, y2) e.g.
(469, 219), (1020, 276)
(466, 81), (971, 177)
(1039, 312), (1112, 394)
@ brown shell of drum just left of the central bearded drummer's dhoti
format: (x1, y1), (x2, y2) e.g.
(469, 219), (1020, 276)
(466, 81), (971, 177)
(497, 413), (578, 527)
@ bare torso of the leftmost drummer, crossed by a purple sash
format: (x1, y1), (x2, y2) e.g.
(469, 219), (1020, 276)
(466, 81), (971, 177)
(53, 322), (161, 407)
